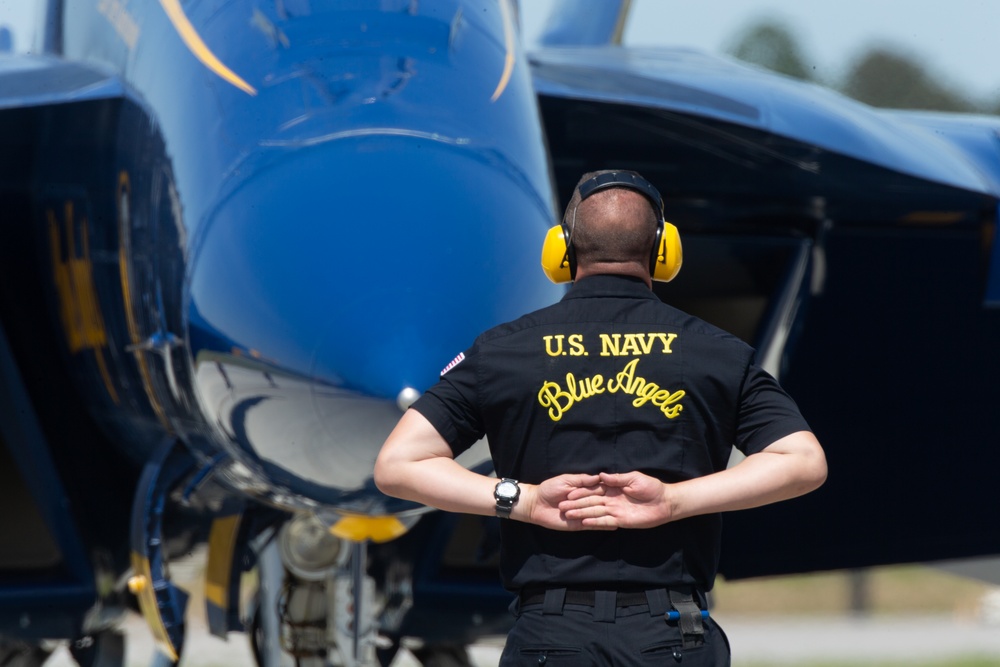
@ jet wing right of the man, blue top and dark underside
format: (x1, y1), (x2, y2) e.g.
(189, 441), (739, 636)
(530, 40), (1000, 578)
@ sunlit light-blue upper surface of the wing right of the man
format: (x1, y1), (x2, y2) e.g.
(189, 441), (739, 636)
(531, 46), (1000, 196)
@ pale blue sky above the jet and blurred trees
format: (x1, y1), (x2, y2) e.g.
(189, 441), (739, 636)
(0, 0), (1000, 100)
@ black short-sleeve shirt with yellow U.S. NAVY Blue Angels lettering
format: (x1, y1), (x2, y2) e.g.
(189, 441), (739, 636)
(413, 275), (809, 590)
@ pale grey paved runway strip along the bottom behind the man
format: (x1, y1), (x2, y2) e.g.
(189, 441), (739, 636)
(46, 616), (1000, 667)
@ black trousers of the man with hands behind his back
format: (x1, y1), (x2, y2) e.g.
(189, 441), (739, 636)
(500, 602), (730, 667)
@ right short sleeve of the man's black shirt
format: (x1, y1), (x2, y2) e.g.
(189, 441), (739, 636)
(736, 364), (811, 455)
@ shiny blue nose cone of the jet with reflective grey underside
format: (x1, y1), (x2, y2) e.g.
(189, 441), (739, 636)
(189, 133), (560, 512)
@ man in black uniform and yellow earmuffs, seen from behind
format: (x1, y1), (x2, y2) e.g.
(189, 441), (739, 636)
(375, 171), (826, 667)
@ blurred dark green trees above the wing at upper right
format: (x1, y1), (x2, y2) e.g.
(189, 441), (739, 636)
(727, 21), (1000, 115)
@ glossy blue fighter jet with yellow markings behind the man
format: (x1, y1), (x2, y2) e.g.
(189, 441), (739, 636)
(0, 0), (1000, 666)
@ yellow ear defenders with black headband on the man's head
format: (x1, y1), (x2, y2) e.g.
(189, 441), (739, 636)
(542, 171), (683, 283)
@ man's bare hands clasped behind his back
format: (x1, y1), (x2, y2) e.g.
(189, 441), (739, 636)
(522, 471), (672, 531)
